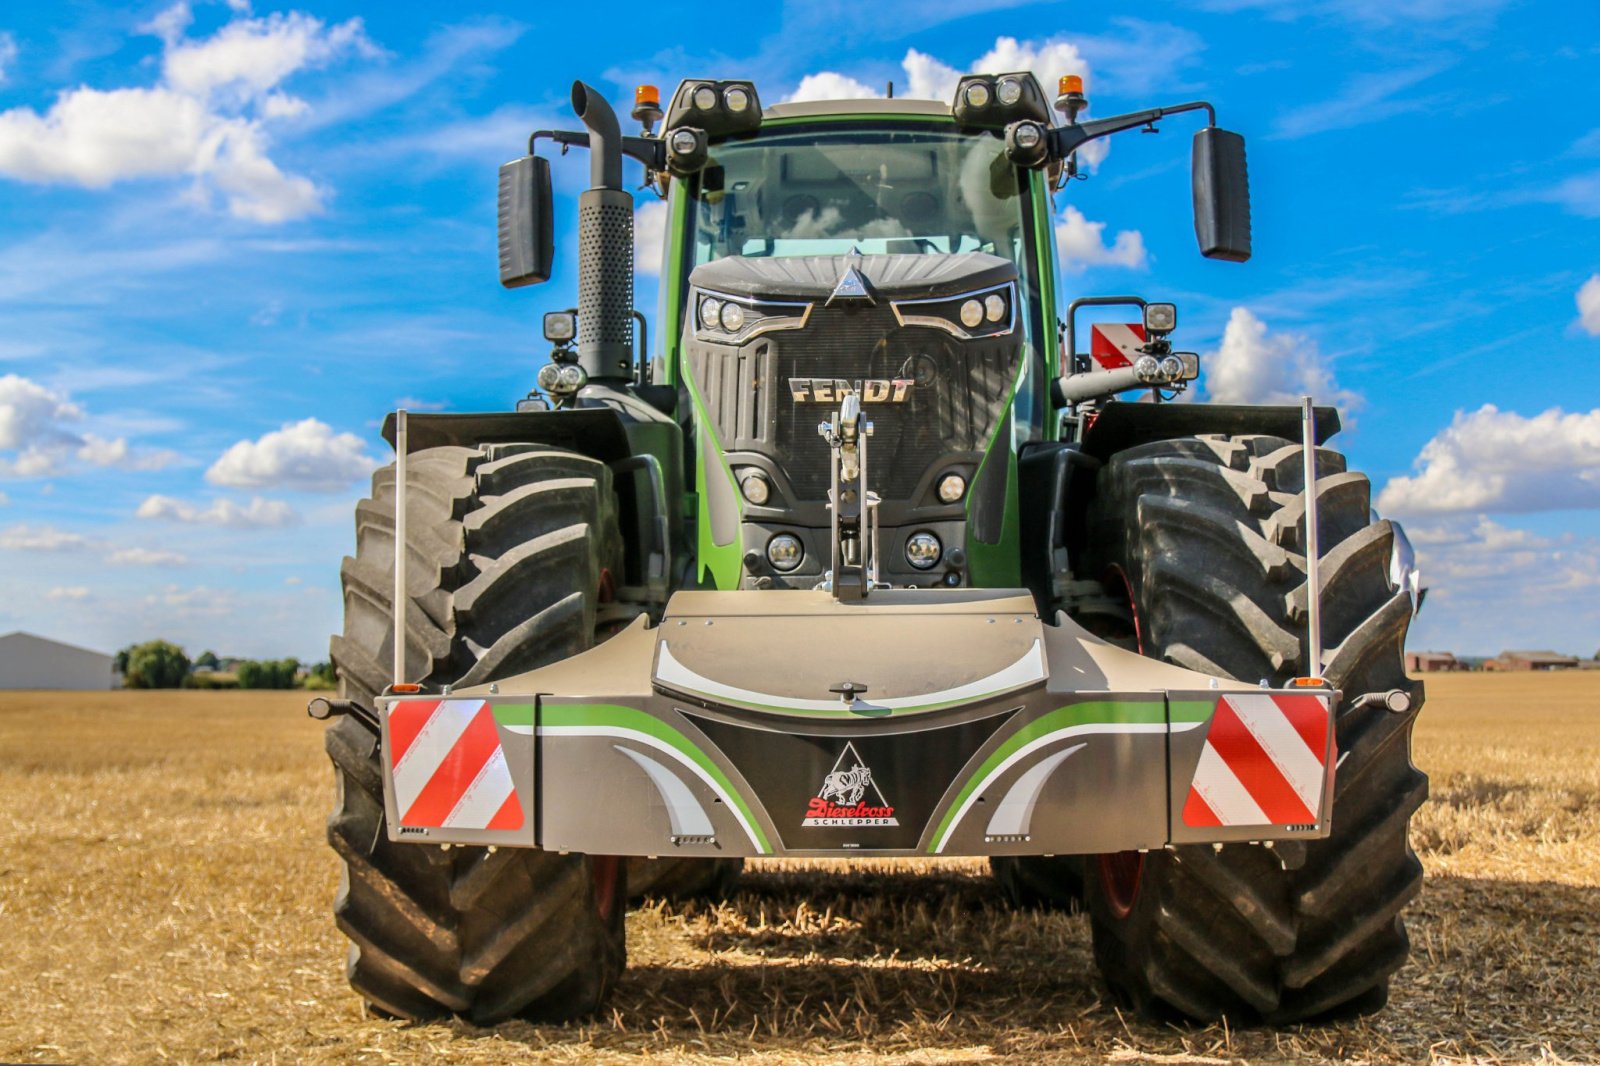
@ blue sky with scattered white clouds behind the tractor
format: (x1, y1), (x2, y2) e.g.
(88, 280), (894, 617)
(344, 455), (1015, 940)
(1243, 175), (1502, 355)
(0, 0), (1600, 659)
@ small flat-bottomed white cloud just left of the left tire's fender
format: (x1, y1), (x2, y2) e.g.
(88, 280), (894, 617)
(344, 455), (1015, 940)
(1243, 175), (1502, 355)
(205, 418), (381, 493)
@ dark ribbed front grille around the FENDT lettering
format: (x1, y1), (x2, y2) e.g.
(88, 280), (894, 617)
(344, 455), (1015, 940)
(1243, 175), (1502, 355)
(683, 303), (1019, 501)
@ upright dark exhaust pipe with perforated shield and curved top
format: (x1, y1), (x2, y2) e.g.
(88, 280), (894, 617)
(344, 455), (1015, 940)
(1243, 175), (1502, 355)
(573, 82), (634, 381)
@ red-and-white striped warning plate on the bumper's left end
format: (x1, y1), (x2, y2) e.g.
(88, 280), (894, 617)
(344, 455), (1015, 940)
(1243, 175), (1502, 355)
(389, 699), (522, 829)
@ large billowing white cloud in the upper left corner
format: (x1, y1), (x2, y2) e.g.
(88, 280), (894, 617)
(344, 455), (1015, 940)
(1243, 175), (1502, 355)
(0, 3), (374, 222)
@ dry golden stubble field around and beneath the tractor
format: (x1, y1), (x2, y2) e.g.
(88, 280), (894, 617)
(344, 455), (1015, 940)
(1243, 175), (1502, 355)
(0, 674), (1600, 1063)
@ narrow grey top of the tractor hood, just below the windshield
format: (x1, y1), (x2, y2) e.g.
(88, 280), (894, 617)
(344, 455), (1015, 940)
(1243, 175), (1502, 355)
(690, 251), (1016, 299)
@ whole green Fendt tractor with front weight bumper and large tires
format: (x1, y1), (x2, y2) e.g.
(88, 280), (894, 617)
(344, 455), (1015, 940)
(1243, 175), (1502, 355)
(312, 74), (1427, 1024)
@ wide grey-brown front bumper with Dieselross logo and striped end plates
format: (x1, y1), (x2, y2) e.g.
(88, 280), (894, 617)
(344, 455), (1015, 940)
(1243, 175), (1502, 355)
(379, 589), (1336, 858)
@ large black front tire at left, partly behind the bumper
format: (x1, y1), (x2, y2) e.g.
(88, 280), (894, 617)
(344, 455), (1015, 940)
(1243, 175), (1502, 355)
(326, 445), (627, 1024)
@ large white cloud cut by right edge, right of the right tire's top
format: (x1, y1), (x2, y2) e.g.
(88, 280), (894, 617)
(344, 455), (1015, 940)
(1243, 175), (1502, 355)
(1378, 403), (1600, 514)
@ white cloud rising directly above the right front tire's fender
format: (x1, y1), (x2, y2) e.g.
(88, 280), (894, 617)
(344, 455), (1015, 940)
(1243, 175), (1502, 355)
(1200, 307), (1362, 408)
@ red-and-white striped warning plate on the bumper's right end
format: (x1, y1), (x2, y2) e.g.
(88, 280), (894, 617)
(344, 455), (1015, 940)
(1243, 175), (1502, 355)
(1184, 693), (1331, 828)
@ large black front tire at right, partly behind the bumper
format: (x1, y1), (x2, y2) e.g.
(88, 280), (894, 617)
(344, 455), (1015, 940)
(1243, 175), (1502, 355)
(1078, 435), (1427, 1024)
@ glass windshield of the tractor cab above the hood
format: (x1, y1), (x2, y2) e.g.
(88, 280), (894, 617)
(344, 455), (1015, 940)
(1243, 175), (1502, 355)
(690, 122), (1024, 266)
